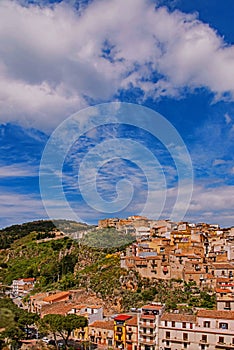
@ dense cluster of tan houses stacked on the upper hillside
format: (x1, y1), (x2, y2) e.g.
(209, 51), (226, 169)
(115, 217), (234, 293)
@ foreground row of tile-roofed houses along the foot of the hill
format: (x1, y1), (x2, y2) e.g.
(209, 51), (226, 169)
(29, 291), (234, 350)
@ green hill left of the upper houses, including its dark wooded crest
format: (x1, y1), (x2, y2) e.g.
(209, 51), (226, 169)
(0, 220), (133, 296)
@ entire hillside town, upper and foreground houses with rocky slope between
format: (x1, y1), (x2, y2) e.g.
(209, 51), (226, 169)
(1, 216), (234, 350)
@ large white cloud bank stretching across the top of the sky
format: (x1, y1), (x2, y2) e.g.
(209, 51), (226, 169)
(0, 0), (234, 129)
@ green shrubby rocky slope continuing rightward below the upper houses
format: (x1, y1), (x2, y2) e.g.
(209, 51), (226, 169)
(0, 222), (215, 312)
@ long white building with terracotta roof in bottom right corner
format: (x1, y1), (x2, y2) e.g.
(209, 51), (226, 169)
(159, 310), (234, 350)
